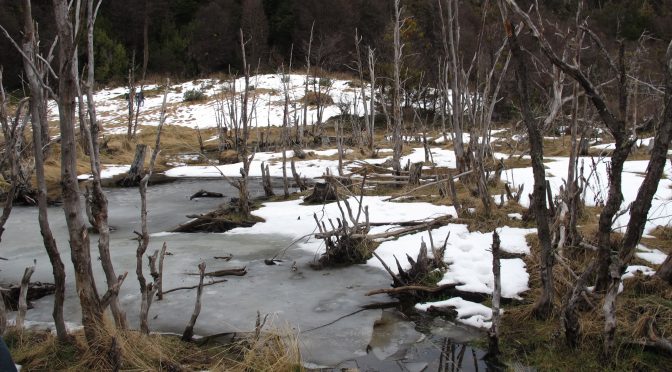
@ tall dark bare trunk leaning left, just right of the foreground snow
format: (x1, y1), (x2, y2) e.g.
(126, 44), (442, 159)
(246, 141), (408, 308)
(505, 21), (554, 318)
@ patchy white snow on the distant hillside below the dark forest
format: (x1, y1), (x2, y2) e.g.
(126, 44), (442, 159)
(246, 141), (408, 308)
(50, 74), (364, 134)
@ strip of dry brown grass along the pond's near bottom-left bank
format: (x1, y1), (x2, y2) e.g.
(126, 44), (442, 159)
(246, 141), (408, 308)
(5, 325), (303, 372)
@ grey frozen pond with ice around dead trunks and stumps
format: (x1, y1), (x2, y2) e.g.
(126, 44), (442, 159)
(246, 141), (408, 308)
(0, 179), (486, 368)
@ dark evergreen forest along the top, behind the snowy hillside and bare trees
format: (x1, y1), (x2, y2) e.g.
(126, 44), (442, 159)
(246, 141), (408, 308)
(0, 0), (672, 88)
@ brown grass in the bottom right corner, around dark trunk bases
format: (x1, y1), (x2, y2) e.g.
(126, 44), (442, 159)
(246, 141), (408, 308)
(500, 234), (672, 371)
